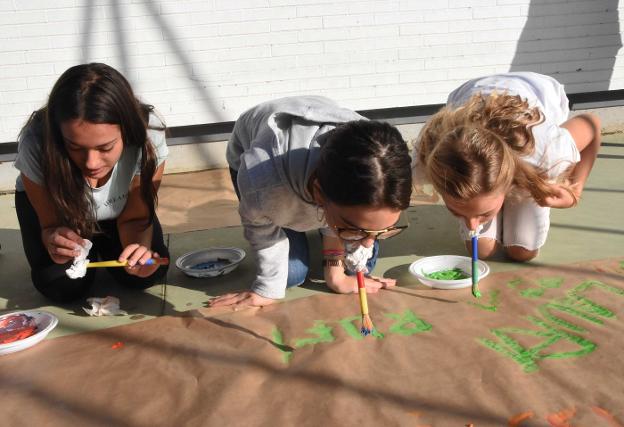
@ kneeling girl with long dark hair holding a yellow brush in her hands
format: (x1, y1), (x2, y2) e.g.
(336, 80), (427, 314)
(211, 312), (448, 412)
(15, 63), (168, 302)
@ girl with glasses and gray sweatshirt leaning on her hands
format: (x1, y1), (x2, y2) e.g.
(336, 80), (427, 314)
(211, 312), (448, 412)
(211, 96), (412, 306)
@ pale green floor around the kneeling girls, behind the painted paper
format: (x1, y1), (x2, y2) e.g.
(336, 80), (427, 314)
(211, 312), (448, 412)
(0, 134), (624, 337)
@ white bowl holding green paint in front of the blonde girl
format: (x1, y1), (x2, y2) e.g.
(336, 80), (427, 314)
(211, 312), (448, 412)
(409, 255), (490, 289)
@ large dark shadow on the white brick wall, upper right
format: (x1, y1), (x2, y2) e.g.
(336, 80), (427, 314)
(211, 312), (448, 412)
(510, 0), (622, 93)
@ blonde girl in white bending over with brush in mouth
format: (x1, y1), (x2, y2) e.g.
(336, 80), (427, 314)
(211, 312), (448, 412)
(415, 72), (600, 261)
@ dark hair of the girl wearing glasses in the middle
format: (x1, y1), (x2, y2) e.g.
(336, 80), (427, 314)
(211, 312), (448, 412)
(315, 120), (412, 210)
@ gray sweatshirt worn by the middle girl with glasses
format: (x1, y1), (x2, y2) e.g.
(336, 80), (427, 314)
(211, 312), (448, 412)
(226, 96), (366, 299)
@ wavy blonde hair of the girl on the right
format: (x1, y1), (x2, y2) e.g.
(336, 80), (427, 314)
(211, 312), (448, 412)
(416, 92), (576, 205)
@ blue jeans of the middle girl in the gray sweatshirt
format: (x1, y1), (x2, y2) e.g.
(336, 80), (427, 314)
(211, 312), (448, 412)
(230, 168), (379, 288)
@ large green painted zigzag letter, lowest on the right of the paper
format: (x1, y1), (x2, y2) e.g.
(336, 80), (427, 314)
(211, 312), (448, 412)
(477, 316), (598, 373)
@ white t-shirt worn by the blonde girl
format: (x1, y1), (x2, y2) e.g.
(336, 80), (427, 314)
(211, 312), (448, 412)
(447, 72), (581, 179)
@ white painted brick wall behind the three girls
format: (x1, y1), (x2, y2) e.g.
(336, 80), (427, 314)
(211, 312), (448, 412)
(0, 0), (624, 142)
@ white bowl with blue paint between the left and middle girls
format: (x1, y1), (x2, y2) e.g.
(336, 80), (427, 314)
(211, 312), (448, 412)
(176, 248), (245, 277)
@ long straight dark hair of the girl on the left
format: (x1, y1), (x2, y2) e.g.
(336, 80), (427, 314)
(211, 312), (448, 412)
(22, 63), (158, 237)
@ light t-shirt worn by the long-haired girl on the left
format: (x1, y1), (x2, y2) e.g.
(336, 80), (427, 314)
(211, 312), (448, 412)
(15, 113), (169, 221)
